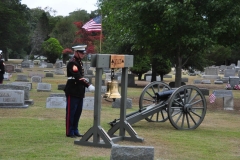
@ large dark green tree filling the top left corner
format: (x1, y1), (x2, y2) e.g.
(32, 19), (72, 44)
(0, 0), (29, 61)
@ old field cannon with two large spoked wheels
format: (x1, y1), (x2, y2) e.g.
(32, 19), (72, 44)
(109, 81), (207, 130)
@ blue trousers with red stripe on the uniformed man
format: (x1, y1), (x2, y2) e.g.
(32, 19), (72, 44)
(66, 96), (83, 136)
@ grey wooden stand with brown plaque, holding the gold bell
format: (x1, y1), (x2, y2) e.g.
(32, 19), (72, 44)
(74, 54), (143, 148)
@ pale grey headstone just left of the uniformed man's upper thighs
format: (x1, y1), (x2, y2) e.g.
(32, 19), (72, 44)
(46, 97), (66, 108)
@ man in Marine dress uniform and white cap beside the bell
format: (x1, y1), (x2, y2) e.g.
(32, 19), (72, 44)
(64, 45), (95, 138)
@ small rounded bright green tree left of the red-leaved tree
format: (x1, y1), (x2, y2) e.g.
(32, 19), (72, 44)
(42, 38), (63, 63)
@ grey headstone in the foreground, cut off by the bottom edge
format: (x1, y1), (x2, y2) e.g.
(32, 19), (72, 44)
(110, 145), (154, 160)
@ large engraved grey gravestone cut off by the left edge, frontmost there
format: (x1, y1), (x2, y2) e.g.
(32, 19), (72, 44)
(0, 90), (28, 108)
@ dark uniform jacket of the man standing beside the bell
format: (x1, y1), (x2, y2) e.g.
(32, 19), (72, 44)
(64, 57), (90, 98)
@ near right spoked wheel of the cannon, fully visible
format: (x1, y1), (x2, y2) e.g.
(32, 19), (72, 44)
(168, 85), (207, 130)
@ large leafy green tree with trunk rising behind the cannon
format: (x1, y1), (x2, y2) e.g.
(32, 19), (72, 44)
(100, 0), (240, 87)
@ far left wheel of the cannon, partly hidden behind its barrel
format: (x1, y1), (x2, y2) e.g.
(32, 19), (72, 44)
(139, 81), (171, 122)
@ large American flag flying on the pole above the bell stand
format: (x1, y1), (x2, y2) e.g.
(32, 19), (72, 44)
(82, 16), (102, 32)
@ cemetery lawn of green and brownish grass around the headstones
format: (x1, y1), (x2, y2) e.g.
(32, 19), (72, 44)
(0, 62), (240, 160)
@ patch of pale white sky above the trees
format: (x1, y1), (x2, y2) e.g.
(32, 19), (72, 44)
(21, 0), (97, 16)
